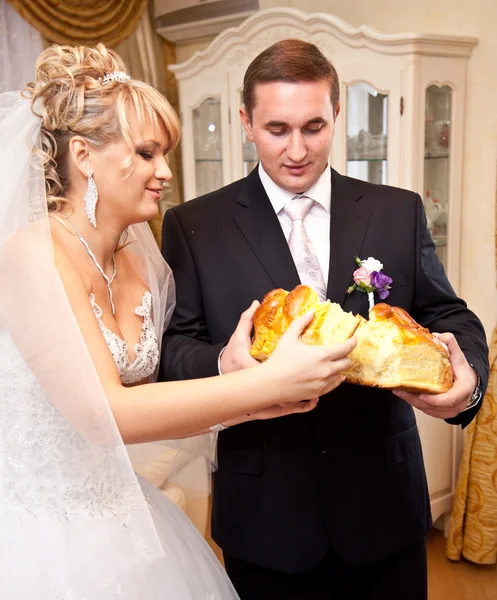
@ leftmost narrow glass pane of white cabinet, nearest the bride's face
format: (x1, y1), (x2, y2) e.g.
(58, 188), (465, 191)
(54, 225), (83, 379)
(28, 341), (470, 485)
(193, 98), (223, 196)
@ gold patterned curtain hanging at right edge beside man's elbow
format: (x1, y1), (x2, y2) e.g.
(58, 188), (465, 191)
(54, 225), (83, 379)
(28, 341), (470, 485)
(446, 327), (497, 565)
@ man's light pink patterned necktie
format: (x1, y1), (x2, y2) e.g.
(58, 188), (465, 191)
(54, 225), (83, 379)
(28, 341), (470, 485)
(283, 196), (326, 300)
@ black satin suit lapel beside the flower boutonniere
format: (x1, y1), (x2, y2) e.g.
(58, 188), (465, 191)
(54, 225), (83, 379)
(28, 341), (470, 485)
(328, 169), (371, 304)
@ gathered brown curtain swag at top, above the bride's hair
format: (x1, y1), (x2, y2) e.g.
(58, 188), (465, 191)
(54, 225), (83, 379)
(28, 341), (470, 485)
(8, 0), (148, 47)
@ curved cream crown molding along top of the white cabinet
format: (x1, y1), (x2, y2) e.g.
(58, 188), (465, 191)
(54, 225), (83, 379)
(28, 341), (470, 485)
(170, 7), (478, 79)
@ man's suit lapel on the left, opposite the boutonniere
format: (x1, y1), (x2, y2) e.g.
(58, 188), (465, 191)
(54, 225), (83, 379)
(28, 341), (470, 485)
(234, 168), (300, 290)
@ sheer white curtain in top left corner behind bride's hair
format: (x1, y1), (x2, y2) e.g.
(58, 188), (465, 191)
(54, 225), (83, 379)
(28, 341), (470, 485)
(0, 0), (43, 93)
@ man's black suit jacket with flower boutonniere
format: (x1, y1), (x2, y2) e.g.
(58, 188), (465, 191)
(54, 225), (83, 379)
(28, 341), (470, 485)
(161, 169), (488, 572)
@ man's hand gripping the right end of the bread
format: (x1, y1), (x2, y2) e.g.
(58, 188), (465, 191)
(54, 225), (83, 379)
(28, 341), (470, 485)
(393, 333), (477, 419)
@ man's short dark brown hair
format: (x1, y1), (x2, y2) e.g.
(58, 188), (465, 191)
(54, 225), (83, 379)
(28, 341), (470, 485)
(243, 39), (340, 120)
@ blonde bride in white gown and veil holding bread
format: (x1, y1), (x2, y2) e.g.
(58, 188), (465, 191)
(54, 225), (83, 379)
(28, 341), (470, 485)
(0, 45), (354, 600)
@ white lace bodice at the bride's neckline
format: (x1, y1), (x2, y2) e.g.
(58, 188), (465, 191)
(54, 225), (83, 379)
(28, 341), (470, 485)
(90, 291), (159, 384)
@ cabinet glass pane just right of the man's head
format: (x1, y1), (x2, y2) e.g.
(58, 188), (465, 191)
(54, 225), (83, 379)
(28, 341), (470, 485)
(347, 82), (388, 184)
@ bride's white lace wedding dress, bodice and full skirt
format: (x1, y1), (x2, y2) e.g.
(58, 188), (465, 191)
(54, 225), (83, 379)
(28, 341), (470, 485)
(0, 292), (238, 600)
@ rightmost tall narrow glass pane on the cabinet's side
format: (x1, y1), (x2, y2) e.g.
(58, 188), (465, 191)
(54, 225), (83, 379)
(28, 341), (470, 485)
(423, 85), (452, 268)
